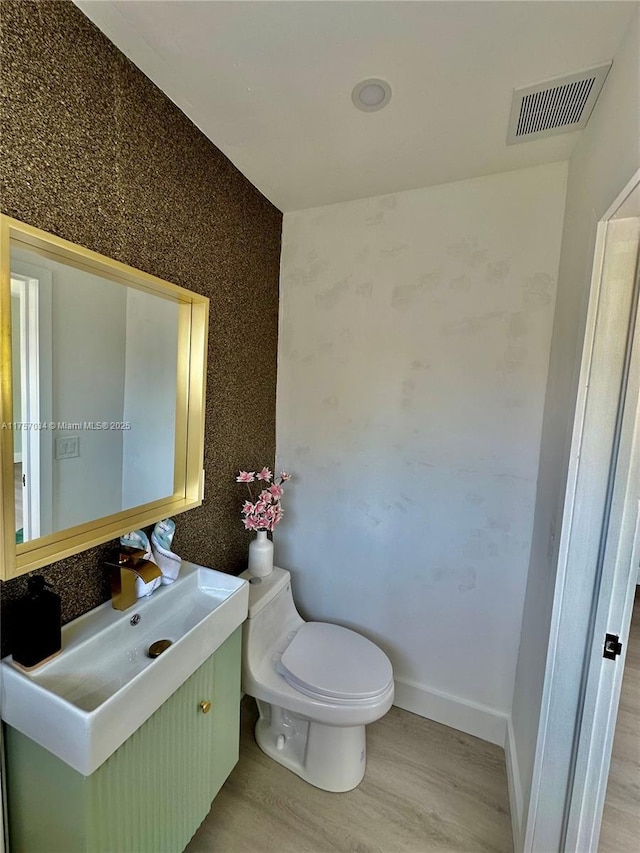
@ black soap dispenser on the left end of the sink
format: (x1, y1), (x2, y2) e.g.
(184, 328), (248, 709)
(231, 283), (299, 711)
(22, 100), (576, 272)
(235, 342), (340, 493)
(13, 575), (62, 669)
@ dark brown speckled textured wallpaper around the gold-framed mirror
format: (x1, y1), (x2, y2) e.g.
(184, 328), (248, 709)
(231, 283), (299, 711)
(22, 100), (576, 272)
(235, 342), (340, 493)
(0, 0), (282, 654)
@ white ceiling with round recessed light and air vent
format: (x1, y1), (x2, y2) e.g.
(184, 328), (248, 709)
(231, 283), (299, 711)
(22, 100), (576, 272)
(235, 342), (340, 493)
(75, 0), (638, 211)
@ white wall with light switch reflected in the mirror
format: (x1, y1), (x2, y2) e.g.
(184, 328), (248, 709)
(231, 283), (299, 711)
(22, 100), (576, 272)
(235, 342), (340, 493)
(50, 258), (127, 530)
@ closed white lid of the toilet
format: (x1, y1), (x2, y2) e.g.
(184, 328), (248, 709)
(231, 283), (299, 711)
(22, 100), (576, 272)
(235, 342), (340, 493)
(280, 622), (393, 700)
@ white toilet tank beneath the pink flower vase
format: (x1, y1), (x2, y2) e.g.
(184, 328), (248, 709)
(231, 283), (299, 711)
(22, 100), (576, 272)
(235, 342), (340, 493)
(240, 566), (304, 668)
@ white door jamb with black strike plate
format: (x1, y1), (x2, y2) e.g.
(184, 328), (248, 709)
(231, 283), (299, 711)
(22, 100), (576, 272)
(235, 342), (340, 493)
(565, 184), (640, 850)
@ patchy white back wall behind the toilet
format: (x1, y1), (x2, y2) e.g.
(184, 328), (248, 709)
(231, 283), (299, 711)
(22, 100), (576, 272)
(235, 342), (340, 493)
(275, 164), (566, 743)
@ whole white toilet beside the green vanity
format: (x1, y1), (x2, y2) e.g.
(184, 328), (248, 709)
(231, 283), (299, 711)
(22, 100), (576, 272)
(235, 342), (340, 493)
(240, 566), (394, 792)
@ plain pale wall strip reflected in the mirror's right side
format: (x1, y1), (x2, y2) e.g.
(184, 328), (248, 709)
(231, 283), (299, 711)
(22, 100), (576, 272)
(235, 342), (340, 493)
(122, 288), (178, 509)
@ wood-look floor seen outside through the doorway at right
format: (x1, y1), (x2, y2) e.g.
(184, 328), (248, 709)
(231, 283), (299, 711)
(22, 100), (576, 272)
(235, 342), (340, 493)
(598, 592), (640, 853)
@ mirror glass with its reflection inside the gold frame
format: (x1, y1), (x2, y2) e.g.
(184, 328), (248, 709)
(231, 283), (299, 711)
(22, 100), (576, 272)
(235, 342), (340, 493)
(11, 245), (179, 543)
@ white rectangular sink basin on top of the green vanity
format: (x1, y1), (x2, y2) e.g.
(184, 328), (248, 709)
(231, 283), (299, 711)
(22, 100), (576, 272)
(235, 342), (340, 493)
(1, 561), (249, 776)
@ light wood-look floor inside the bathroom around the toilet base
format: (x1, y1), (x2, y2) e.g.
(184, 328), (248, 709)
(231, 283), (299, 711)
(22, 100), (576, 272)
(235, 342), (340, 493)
(186, 697), (513, 853)
